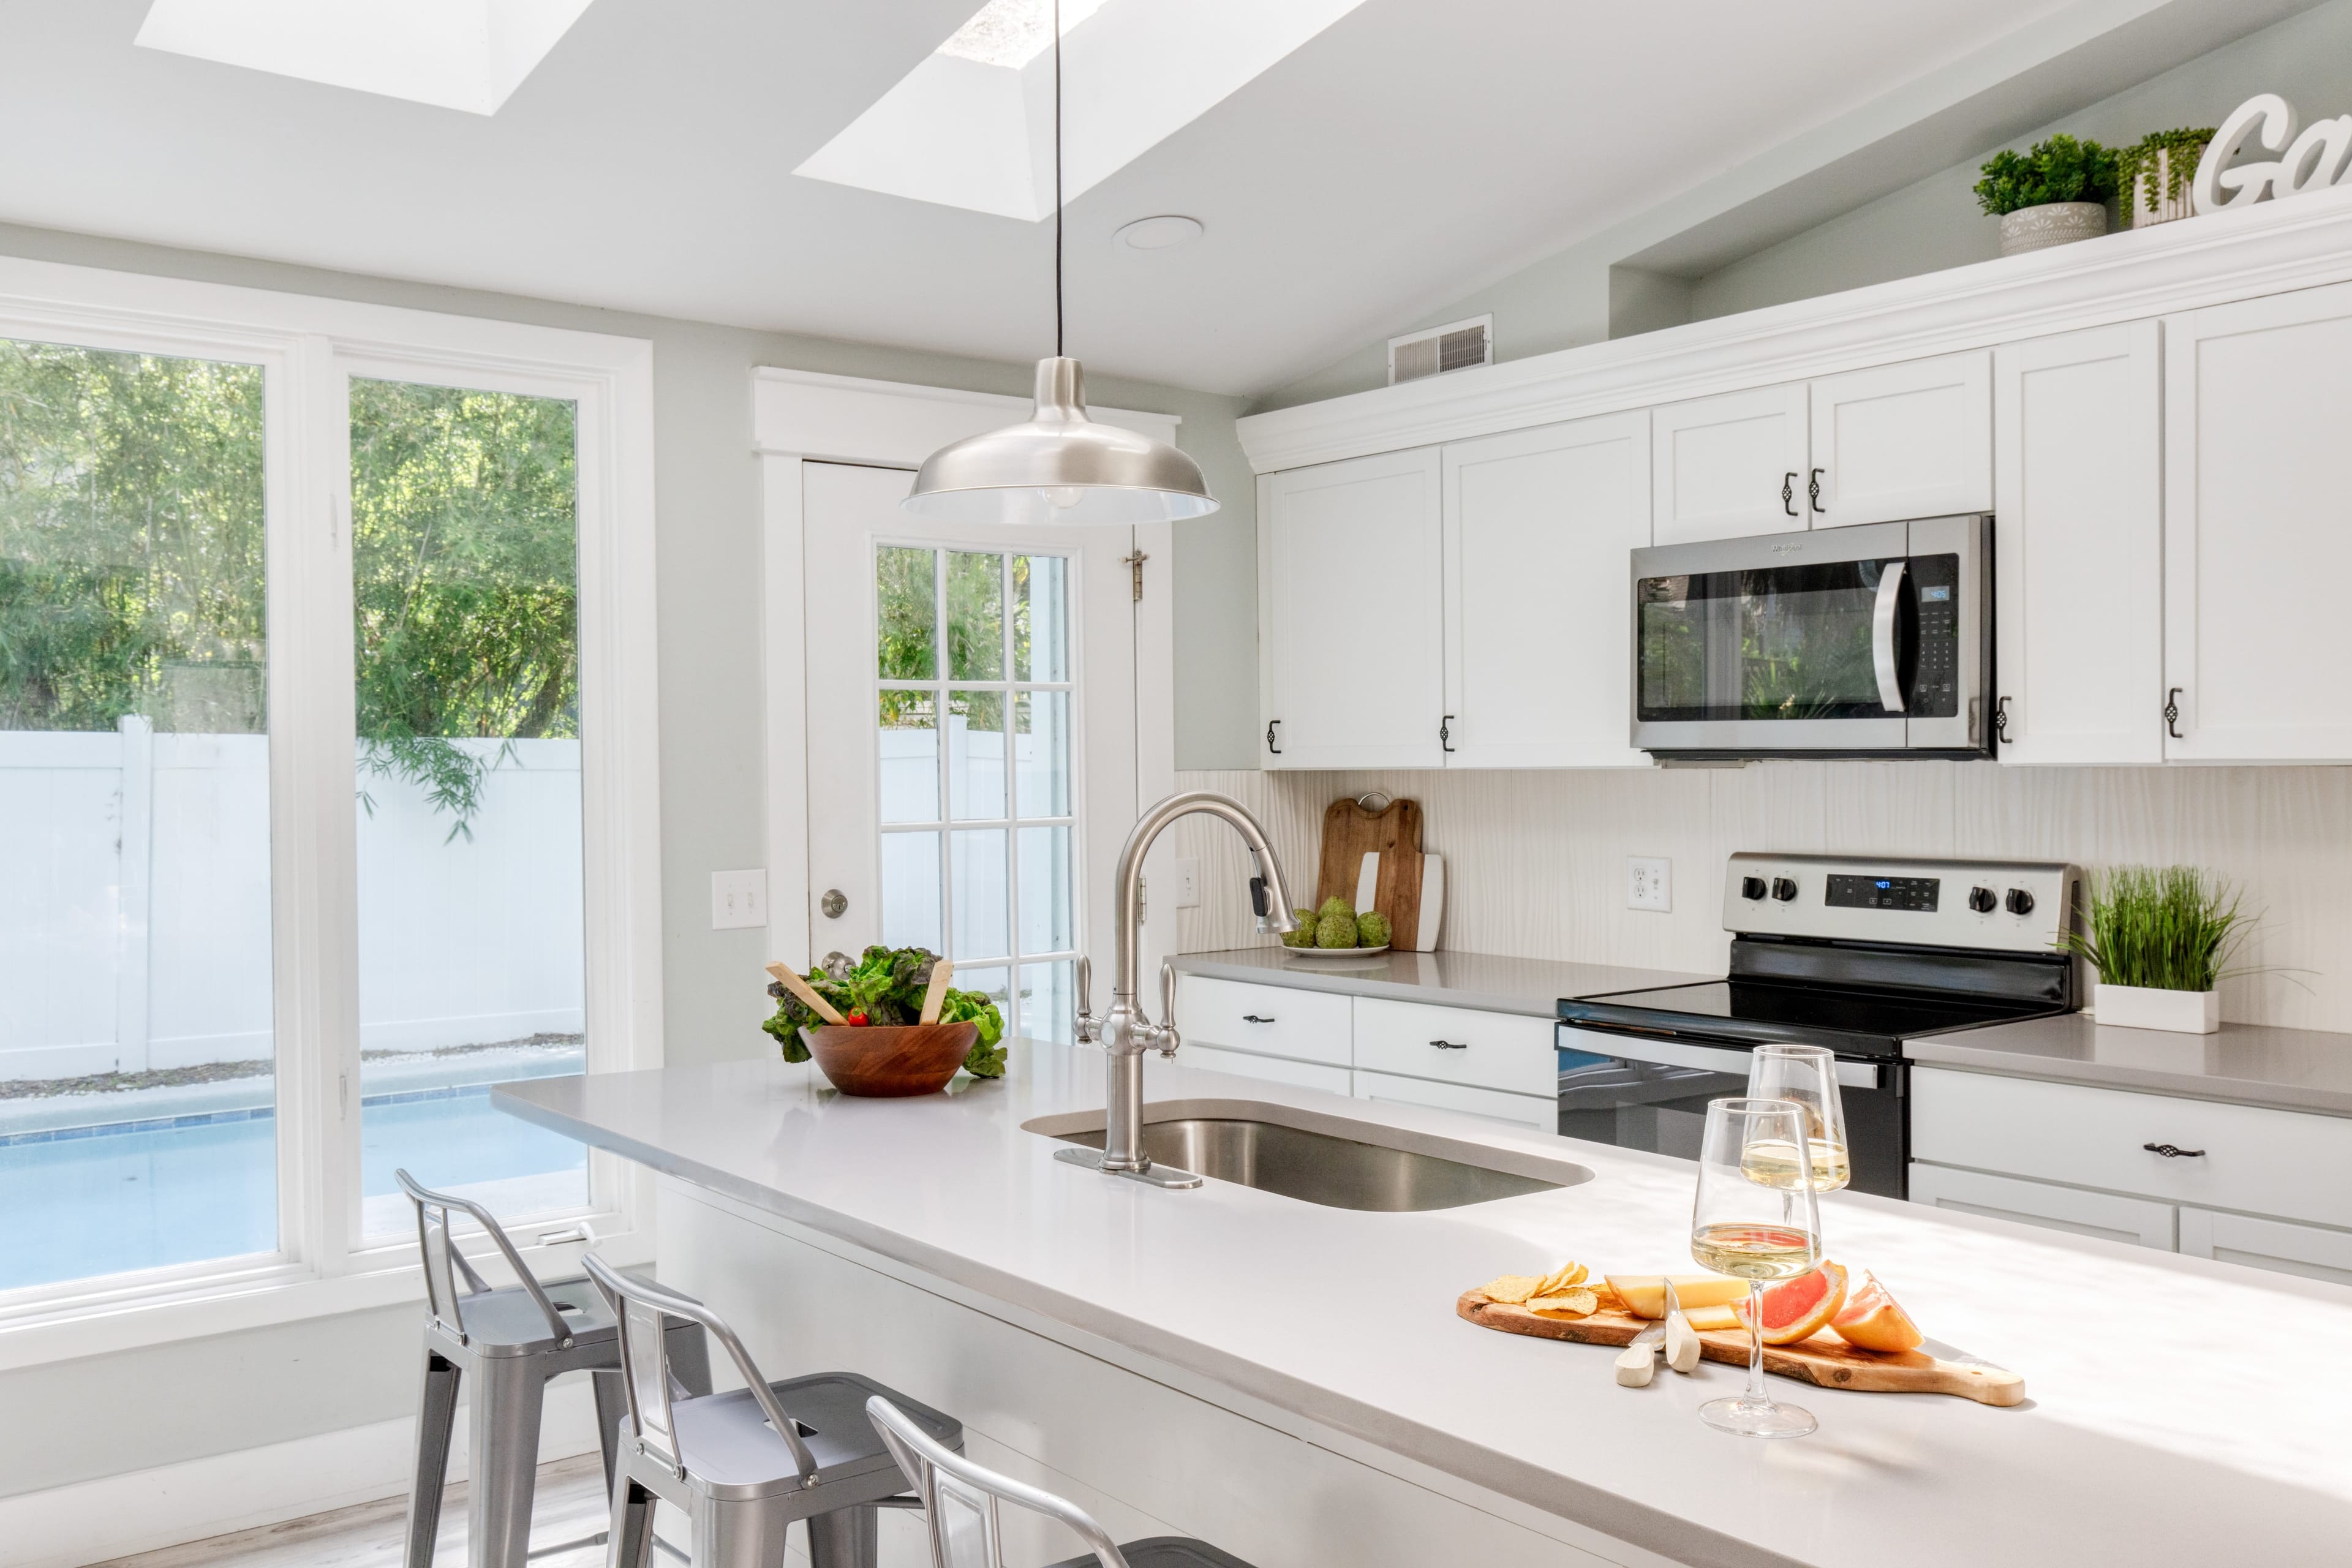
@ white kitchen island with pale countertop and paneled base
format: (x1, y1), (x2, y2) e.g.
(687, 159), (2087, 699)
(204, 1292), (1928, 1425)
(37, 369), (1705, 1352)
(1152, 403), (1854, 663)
(496, 1044), (2352, 1568)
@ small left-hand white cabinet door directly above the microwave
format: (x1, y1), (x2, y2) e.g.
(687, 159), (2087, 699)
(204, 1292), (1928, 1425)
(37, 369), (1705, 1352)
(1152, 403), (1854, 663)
(1627, 381), (1809, 545)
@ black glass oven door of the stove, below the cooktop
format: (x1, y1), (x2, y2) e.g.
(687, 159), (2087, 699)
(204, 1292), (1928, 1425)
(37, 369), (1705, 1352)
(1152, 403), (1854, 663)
(1557, 1025), (1910, 1197)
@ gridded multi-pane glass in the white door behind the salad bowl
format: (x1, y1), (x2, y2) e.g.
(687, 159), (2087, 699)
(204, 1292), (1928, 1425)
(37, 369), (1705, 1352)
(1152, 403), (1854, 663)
(875, 545), (1080, 1039)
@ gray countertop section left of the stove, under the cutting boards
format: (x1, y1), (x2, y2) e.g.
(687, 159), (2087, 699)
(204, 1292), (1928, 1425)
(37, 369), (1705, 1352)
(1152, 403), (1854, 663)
(1171, 948), (1722, 1018)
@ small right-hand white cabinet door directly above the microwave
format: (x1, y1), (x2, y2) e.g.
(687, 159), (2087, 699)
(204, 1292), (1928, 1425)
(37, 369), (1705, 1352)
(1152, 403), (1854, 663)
(1797, 353), (1992, 529)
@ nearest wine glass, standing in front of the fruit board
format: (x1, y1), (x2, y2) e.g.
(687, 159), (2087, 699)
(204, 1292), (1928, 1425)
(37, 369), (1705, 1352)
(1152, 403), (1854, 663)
(1691, 1100), (1820, 1436)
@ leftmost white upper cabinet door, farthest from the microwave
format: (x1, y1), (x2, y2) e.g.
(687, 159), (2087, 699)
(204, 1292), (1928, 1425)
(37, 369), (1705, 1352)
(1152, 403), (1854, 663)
(1258, 447), (1444, 769)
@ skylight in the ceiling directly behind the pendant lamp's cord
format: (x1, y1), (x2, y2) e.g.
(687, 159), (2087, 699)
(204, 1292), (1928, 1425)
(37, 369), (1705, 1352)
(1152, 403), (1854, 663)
(795, 0), (1364, 221)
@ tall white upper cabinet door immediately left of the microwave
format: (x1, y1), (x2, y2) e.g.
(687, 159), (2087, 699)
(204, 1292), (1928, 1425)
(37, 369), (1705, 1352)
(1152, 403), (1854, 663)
(1444, 409), (1651, 769)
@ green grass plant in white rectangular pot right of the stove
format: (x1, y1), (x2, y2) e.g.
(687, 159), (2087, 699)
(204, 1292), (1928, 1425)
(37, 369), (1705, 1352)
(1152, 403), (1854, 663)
(2060, 865), (2253, 1035)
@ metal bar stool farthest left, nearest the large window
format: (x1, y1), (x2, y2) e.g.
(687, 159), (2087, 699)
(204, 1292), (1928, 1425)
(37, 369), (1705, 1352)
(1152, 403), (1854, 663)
(393, 1170), (710, 1568)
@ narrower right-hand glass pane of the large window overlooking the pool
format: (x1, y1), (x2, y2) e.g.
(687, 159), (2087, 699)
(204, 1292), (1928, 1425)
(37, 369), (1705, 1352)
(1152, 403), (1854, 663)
(350, 379), (588, 1234)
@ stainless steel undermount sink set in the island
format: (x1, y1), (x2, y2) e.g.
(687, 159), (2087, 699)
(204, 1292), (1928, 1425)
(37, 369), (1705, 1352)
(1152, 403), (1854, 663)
(1023, 1100), (1593, 1213)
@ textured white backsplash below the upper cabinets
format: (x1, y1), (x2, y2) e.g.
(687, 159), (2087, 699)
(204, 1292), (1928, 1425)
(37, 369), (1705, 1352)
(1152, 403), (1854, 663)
(1171, 762), (2352, 1030)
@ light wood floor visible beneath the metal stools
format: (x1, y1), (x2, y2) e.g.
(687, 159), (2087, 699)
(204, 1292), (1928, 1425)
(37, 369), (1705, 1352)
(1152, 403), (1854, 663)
(96, 1453), (644, 1568)
